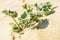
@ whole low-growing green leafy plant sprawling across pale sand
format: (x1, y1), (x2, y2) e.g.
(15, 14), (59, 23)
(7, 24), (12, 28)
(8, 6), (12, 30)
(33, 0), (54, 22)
(2, 2), (53, 39)
